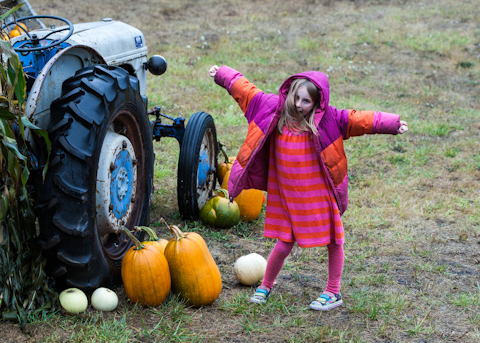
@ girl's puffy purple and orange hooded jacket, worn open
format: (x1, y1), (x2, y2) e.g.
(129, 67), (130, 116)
(214, 66), (400, 214)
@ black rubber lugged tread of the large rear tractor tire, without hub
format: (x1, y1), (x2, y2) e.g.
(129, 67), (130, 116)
(36, 66), (153, 289)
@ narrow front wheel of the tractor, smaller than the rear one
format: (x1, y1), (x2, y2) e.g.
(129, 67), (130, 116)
(177, 112), (218, 220)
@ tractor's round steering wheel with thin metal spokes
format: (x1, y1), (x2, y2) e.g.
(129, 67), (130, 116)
(2, 15), (73, 53)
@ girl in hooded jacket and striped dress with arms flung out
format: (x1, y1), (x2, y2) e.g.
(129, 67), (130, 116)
(209, 66), (408, 311)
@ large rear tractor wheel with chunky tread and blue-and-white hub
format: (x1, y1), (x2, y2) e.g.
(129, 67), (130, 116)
(37, 65), (154, 290)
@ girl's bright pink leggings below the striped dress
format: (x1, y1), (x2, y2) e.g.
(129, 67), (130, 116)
(262, 240), (343, 294)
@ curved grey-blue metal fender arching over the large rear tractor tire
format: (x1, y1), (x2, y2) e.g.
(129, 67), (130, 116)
(25, 45), (106, 130)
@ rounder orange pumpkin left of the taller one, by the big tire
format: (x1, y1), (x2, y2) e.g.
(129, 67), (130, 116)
(121, 227), (171, 306)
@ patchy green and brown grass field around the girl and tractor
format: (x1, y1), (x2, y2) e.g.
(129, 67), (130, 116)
(0, 0), (480, 342)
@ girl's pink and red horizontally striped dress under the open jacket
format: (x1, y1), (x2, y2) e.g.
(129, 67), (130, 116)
(264, 127), (344, 248)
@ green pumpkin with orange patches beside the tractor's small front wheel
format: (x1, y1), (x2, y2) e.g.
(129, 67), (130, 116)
(200, 189), (240, 228)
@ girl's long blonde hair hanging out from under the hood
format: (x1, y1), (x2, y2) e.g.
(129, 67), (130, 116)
(277, 79), (320, 136)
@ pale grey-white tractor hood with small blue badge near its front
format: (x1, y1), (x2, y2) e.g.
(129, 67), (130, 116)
(63, 19), (147, 65)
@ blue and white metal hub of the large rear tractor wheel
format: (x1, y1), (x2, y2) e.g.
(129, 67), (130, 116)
(96, 130), (137, 236)
